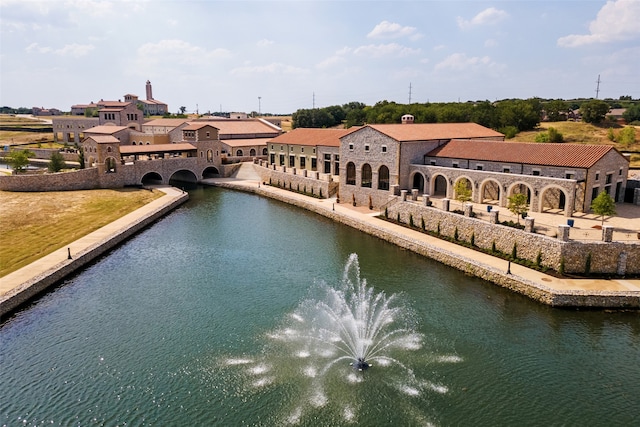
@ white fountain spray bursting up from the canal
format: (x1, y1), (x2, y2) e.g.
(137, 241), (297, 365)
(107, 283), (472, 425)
(225, 254), (460, 424)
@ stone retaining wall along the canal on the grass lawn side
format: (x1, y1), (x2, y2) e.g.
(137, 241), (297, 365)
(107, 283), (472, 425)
(0, 193), (189, 317)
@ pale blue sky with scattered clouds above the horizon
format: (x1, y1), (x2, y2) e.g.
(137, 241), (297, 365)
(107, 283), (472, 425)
(0, 0), (640, 114)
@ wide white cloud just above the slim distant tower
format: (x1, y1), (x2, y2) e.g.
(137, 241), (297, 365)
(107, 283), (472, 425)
(138, 39), (231, 68)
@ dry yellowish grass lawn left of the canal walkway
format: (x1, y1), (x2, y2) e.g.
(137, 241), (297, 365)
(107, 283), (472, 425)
(0, 189), (164, 277)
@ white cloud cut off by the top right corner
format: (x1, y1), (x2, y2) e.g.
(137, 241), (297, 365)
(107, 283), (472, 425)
(558, 0), (640, 47)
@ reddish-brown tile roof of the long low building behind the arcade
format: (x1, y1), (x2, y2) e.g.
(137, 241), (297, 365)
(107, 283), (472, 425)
(427, 140), (615, 168)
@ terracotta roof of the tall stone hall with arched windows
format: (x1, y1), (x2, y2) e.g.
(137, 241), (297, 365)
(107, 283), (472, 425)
(367, 123), (504, 142)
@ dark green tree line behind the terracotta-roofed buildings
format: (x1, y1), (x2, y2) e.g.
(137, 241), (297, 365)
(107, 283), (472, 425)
(292, 97), (640, 137)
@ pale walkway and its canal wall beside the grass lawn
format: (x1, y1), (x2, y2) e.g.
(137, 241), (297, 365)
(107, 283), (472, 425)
(0, 186), (189, 318)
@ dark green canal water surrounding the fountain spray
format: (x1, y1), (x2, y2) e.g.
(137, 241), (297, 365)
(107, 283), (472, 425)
(0, 188), (640, 426)
